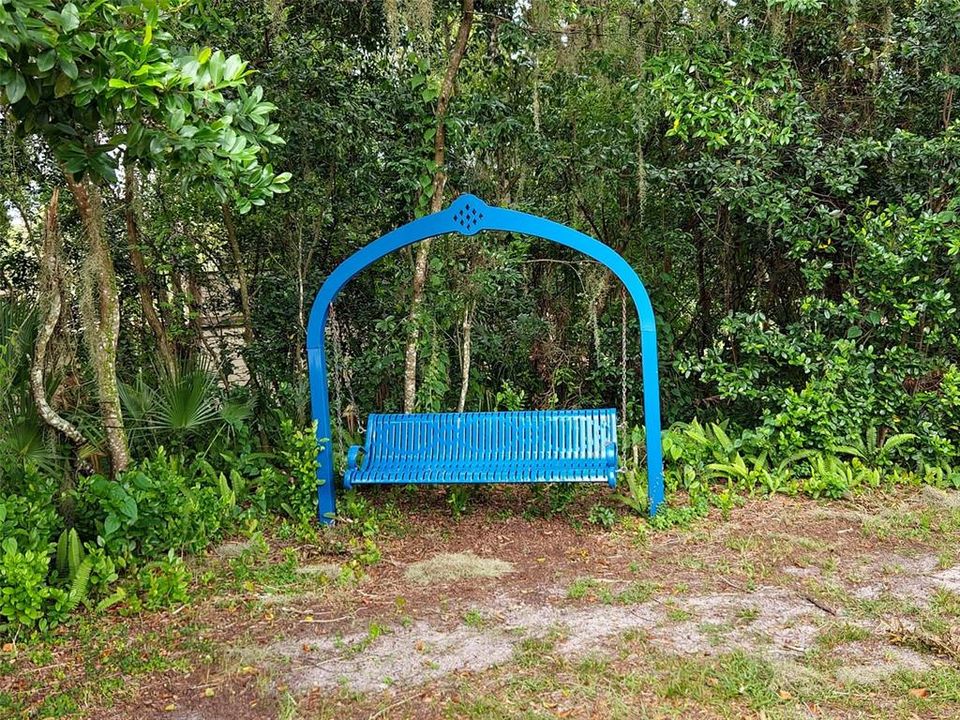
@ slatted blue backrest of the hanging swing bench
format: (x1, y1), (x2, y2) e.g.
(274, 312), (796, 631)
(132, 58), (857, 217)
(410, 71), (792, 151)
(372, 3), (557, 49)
(366, 409), (617, 464)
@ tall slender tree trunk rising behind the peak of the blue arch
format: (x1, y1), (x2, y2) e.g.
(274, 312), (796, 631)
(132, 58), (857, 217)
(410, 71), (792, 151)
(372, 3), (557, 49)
(403, 0), (474, 413)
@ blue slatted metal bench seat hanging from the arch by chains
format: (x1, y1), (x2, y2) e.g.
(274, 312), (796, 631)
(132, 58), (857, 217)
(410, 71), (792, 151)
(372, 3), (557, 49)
(343, 409), (617, 488)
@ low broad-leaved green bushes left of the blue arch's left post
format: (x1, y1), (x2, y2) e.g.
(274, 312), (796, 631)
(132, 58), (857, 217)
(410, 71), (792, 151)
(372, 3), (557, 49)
(0, 420), (316, 634)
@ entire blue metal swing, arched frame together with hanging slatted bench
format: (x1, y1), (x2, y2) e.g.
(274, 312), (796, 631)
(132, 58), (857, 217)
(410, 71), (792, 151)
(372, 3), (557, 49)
(307, 195), (664, 523)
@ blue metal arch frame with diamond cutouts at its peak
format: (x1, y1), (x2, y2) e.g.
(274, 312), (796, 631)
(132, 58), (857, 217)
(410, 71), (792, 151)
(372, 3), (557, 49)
(307, 195), (663, 522)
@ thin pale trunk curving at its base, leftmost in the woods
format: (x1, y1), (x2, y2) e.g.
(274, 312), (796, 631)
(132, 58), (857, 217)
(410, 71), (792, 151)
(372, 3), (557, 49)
(30, 188), (88, 446)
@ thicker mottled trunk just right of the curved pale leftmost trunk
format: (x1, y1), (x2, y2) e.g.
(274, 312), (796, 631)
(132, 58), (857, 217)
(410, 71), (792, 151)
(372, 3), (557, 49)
(64, 172), (130, 475)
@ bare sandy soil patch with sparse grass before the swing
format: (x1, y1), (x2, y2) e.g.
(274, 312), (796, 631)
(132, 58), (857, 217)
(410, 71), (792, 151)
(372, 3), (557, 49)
(7, 489), (960, 720)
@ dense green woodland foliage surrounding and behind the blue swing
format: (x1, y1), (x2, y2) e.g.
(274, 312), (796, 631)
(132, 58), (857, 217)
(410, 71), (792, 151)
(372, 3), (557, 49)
(0, 0), (960, 631)
